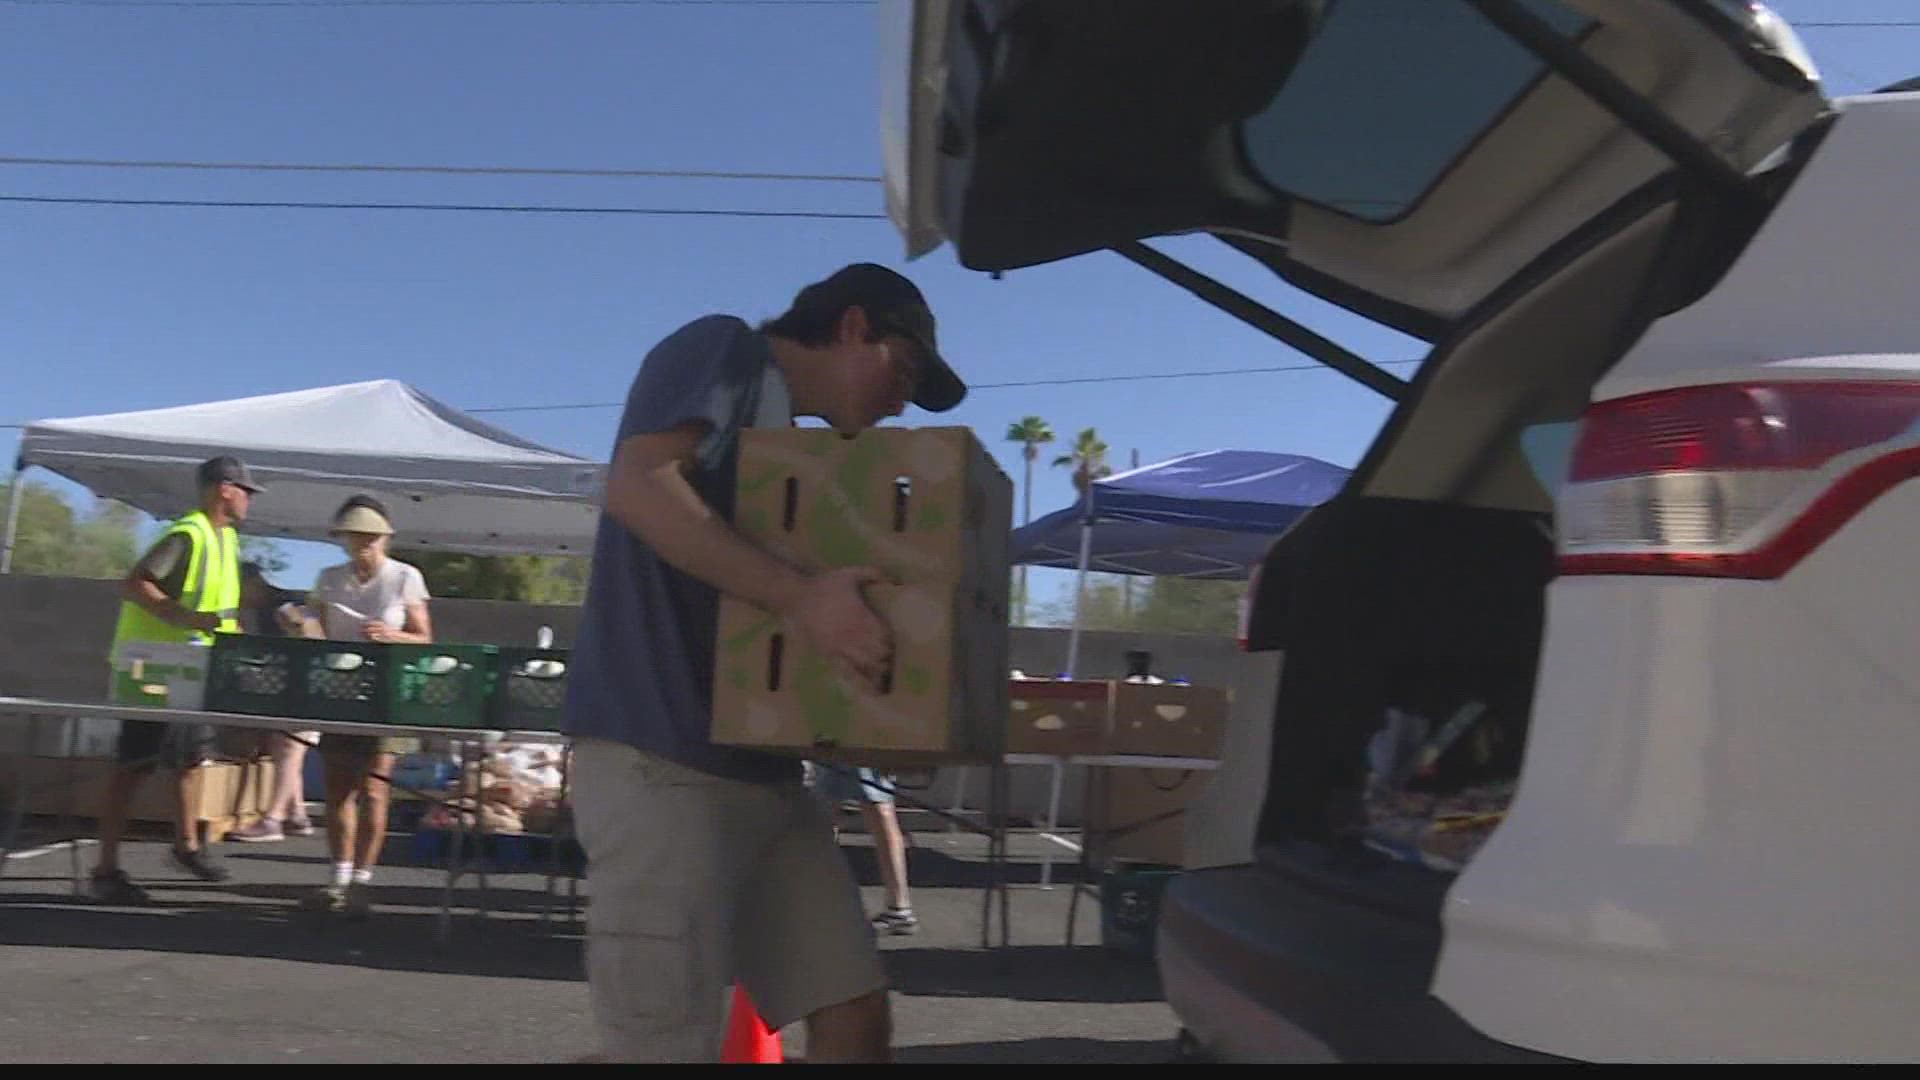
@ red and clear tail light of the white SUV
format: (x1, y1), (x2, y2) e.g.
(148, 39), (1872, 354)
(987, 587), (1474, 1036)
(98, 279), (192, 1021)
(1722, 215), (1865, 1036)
(1559, 380), (1920, 578)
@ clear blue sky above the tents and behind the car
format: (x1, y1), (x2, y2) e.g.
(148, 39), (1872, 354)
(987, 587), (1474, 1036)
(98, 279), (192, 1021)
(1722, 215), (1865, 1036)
(0, 0), (1920, 595)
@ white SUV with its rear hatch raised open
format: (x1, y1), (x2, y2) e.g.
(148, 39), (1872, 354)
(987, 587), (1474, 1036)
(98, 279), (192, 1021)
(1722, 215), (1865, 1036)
(883, 0), (1920, 1061)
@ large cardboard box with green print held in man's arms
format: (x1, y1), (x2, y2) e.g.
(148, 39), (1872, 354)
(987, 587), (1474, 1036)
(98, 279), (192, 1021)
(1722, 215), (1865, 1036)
(712, 429), (1014, 767)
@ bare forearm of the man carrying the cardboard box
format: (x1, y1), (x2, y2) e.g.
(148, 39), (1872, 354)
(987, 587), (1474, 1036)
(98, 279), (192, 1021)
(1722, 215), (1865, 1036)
(607, 469), (806, 613)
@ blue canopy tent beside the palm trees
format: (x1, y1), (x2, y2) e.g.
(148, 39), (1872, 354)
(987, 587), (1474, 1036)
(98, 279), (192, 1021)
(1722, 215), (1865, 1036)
(1012, 450), (1348, 673)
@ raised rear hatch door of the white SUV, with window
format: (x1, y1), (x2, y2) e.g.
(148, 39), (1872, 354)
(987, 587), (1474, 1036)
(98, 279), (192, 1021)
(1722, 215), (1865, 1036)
(883, 0), (1826, 340)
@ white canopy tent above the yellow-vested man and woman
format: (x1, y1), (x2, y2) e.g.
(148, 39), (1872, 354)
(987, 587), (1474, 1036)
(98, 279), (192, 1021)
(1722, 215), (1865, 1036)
(0, 379), (607, 571)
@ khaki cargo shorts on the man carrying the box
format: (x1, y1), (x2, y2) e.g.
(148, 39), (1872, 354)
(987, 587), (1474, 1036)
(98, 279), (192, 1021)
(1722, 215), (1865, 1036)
(572, 740), (887, 1063)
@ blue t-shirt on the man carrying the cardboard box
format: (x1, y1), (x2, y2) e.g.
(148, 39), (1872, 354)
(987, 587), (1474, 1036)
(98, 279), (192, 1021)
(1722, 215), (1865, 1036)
(564, 315), (801, 782)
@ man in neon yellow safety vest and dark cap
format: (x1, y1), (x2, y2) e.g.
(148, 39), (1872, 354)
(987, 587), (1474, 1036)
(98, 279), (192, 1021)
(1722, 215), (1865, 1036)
(92, 457), (261, 905)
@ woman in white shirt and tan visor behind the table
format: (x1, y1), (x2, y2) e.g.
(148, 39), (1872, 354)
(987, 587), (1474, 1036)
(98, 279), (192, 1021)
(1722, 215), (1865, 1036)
(293, 496), (434, 917)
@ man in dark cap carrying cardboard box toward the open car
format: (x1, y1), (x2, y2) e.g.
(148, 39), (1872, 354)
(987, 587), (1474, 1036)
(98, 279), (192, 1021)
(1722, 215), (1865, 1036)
(564, 263), (966, 1061)
